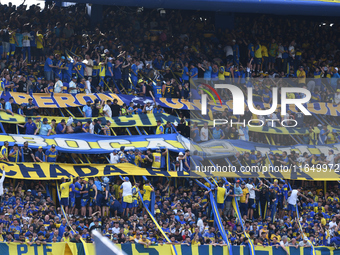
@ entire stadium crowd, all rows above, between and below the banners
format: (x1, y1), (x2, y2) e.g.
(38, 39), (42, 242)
(0, 0), (340, 249)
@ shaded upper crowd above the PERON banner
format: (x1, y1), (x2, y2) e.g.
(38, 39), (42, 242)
(0, 5), (340, 97)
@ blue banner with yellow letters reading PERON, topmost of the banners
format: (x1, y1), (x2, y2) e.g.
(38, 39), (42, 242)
(1, 92), (340, 116)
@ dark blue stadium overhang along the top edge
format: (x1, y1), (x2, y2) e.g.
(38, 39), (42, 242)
(74, 0), (340, 16)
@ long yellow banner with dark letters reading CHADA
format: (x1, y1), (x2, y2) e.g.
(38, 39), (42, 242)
(1, 162), (340, 181)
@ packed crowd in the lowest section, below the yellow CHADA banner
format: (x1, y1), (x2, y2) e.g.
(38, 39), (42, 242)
(0, 169), (340, 247)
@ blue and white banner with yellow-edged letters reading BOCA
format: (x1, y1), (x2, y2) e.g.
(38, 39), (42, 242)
(0, 133), (190, 154)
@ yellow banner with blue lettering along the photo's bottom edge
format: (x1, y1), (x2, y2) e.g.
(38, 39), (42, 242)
(0, 243), (340, 255)
